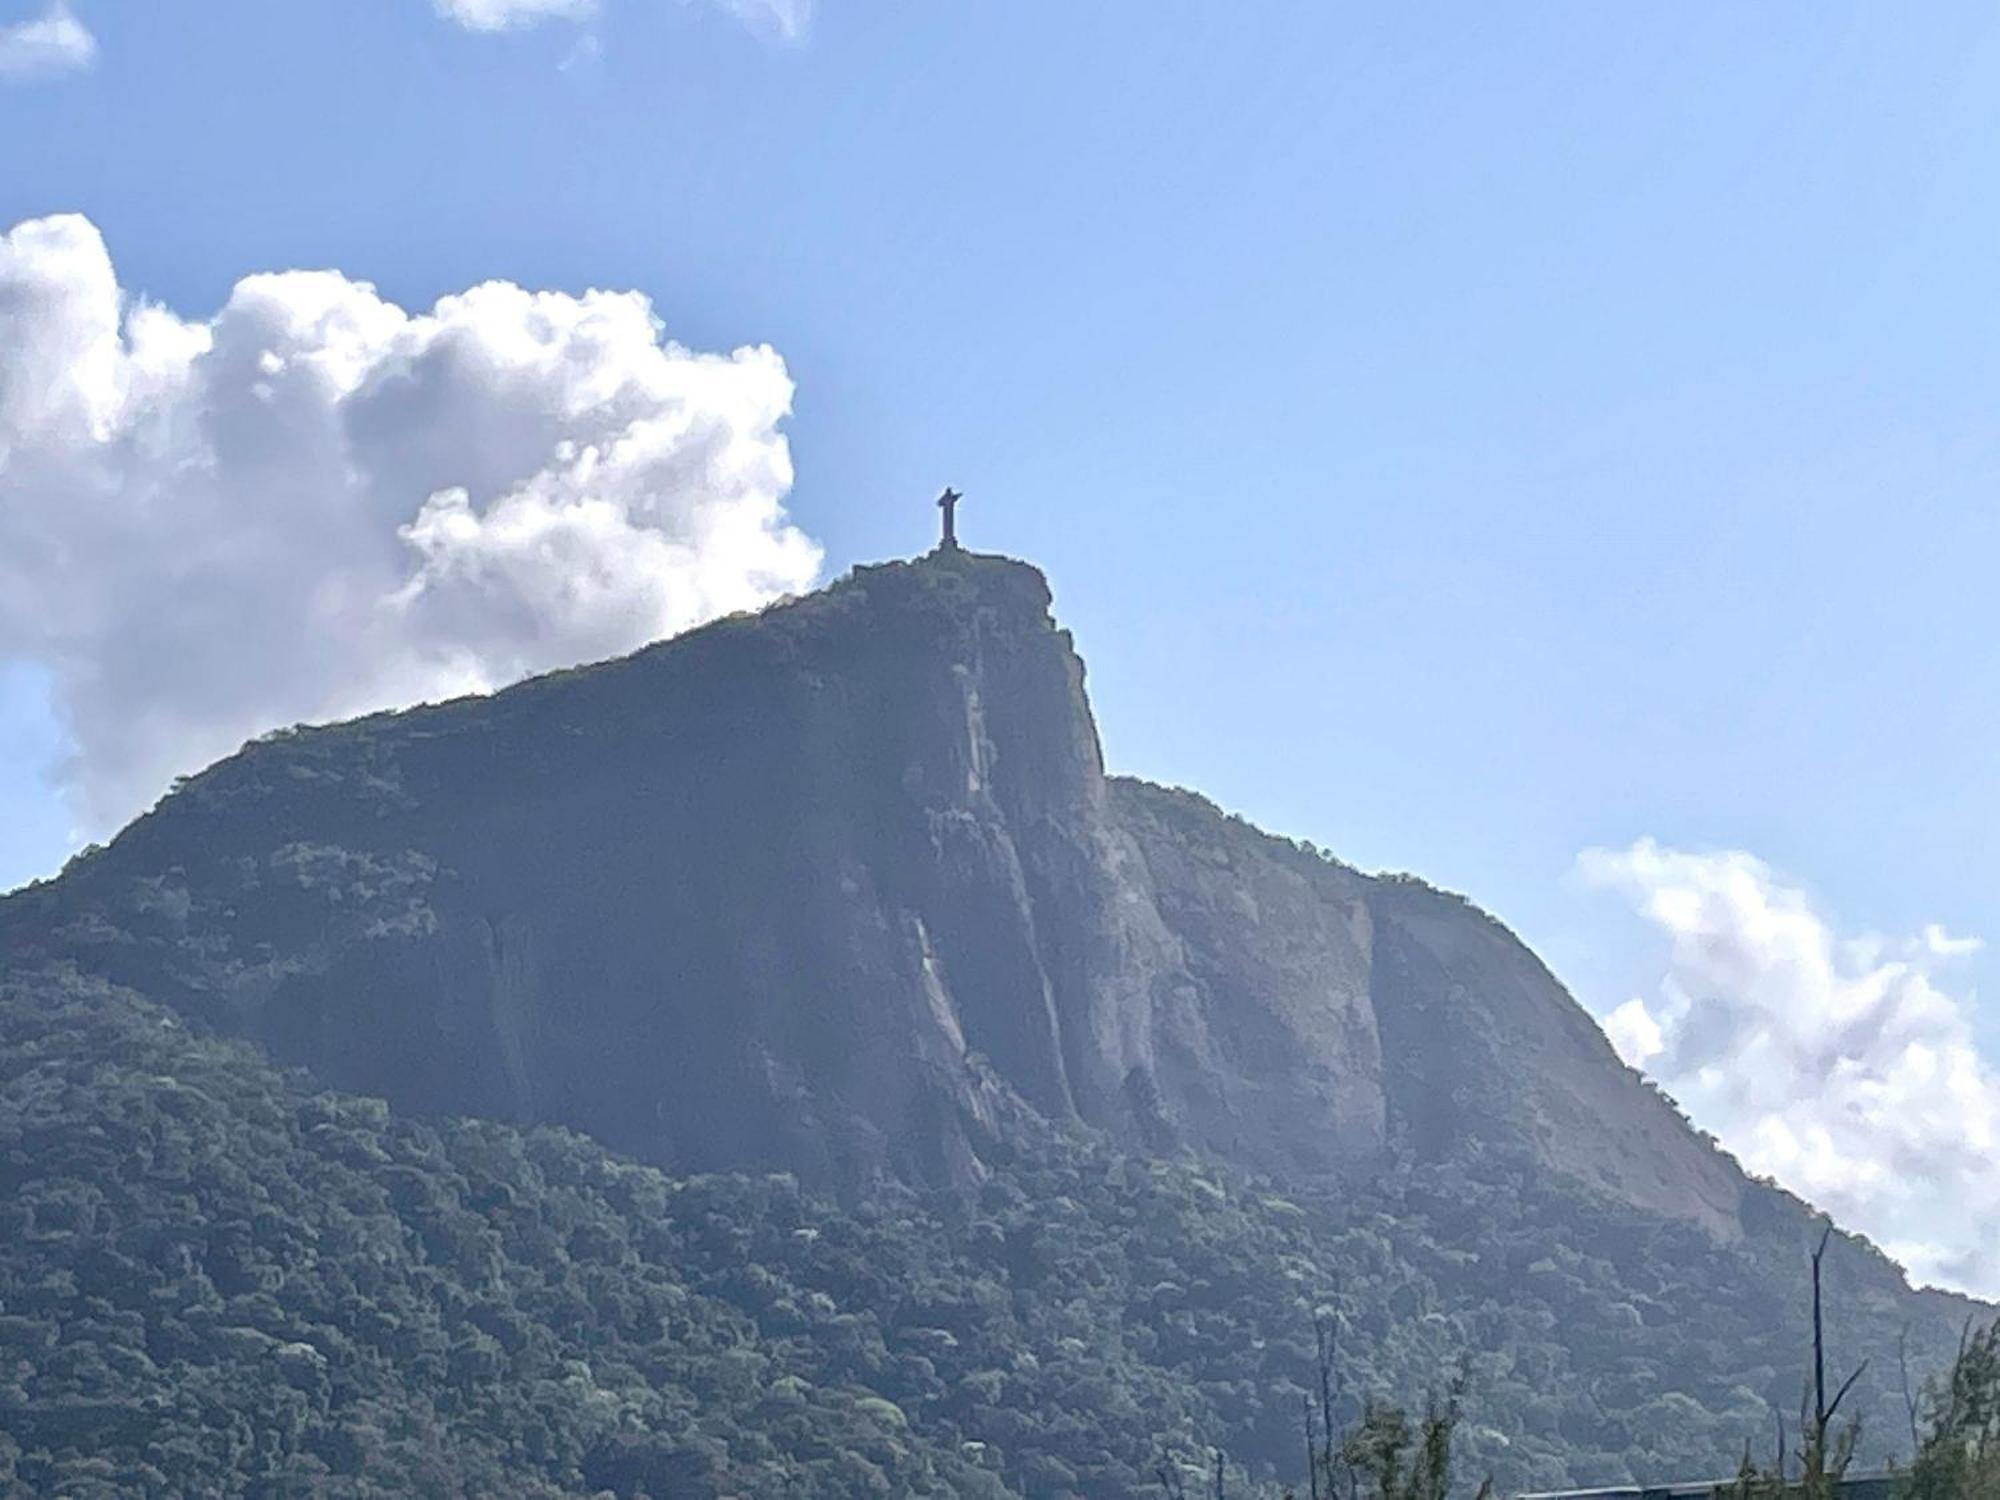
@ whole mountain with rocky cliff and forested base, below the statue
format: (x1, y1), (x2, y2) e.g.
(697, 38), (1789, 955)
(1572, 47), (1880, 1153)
(0, 550), (1976, 1496)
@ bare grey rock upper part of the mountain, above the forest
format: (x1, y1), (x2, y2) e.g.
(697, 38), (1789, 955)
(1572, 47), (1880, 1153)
(0, 552), (1742, 1238)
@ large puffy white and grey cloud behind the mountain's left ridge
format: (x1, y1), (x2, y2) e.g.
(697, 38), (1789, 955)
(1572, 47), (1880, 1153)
(0, 216), (820, 828)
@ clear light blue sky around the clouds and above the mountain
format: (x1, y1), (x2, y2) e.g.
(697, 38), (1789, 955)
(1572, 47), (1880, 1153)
(0, 0), (2000, 1280)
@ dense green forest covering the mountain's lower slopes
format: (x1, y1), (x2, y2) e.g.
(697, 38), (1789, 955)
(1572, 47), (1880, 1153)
(0, 972), (1956, 1498)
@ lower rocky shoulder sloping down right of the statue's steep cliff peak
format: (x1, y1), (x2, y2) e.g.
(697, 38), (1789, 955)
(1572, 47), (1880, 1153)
(1112, 780), (1744, 1238)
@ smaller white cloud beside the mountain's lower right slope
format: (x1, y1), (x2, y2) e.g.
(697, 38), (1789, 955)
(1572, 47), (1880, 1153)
(1580, 840), (2000, 1294)
